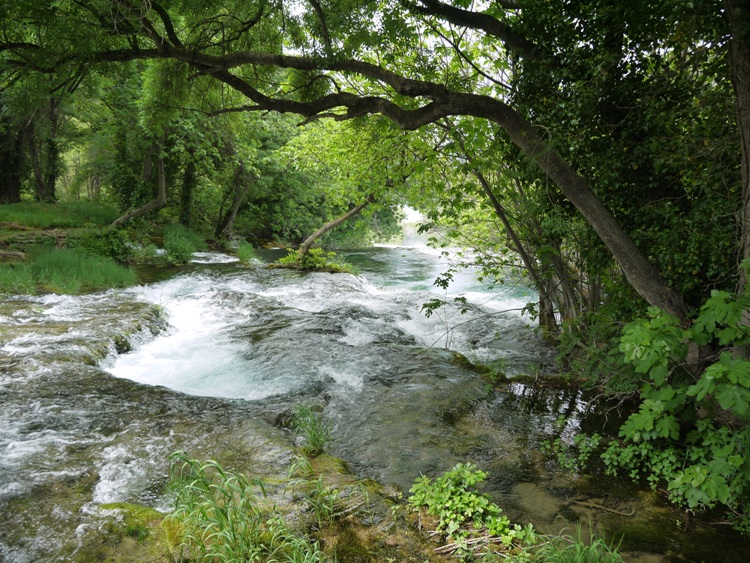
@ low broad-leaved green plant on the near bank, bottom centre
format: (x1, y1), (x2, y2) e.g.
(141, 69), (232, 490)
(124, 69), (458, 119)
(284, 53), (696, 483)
(409, 463), (536, 556)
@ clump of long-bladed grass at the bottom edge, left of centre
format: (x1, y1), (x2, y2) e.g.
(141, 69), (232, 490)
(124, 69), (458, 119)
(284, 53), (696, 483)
(162, 452), (323, 563)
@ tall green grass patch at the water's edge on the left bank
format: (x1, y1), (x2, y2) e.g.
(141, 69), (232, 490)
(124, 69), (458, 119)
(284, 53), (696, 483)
(0, 248), (136, 294)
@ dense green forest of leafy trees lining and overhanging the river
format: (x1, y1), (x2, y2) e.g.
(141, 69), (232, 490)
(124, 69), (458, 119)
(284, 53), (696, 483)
(0, 0), (750, 556)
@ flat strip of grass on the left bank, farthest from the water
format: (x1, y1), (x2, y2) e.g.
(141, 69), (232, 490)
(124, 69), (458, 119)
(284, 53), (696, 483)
(0, 201), (119, 229)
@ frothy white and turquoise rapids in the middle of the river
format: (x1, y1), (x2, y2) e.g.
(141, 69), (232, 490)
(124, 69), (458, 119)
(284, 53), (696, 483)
(105, 248), (539, 400)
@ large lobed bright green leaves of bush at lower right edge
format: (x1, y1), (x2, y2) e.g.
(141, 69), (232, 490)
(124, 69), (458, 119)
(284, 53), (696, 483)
(603, 291), (750, 530)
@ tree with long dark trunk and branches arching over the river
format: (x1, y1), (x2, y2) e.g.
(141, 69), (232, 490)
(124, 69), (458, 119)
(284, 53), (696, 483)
(2, 0), (748, 319)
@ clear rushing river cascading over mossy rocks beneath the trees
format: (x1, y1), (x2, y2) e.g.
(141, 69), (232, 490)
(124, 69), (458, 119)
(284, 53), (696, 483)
(0, 247), (750, 562)
